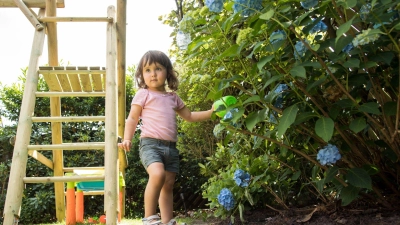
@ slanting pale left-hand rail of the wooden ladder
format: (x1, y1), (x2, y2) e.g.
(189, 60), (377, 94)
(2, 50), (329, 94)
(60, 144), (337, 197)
(3, 10), (45, 224)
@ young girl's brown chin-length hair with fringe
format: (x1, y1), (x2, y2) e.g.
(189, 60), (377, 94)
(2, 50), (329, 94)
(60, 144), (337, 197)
(135, 50), (179, 91)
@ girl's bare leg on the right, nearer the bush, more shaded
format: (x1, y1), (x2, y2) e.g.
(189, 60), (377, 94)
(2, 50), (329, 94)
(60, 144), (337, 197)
(158, 171), (176, 223)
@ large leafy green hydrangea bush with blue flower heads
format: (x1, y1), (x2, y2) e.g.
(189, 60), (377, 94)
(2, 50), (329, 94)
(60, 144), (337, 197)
(163, 0), (400, 221)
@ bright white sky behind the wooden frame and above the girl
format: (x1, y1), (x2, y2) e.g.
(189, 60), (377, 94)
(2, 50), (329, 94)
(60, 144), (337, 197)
(0, 0), (176, 85)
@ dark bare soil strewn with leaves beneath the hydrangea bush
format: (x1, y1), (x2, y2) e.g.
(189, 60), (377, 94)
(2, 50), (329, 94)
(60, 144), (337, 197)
(181, 202), (400, 225)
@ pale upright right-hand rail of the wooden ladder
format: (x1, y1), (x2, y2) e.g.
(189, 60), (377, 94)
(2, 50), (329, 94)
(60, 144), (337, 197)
(104, 6), (118, 225)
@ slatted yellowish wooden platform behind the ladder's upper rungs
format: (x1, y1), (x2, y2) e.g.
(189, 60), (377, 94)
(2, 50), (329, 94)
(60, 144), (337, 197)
(39, 66), (106, 92)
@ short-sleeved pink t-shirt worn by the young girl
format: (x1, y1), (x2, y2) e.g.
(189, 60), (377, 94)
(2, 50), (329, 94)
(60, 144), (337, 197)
(132, 89), (185, 142)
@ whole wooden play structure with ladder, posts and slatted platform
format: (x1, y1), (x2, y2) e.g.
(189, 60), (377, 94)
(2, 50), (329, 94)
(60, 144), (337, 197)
(0, 0), (127, 225)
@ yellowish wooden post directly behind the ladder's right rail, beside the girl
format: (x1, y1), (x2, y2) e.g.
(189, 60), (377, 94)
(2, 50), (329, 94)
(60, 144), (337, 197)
(117, 0), (127, 217)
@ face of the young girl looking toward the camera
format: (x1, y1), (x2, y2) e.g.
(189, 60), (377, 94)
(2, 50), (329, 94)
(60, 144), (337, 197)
(143, 63), (167, 92)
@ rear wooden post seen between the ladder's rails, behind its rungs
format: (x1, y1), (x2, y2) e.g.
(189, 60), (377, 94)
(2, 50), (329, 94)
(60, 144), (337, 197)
(46, 0), (65, 222)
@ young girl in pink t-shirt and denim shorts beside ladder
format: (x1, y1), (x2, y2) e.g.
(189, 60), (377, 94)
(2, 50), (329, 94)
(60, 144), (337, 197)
(119, 51), (213, 225)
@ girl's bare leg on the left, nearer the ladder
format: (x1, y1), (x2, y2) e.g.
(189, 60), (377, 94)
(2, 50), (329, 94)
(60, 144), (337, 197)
(144, 162), (167, 218)
